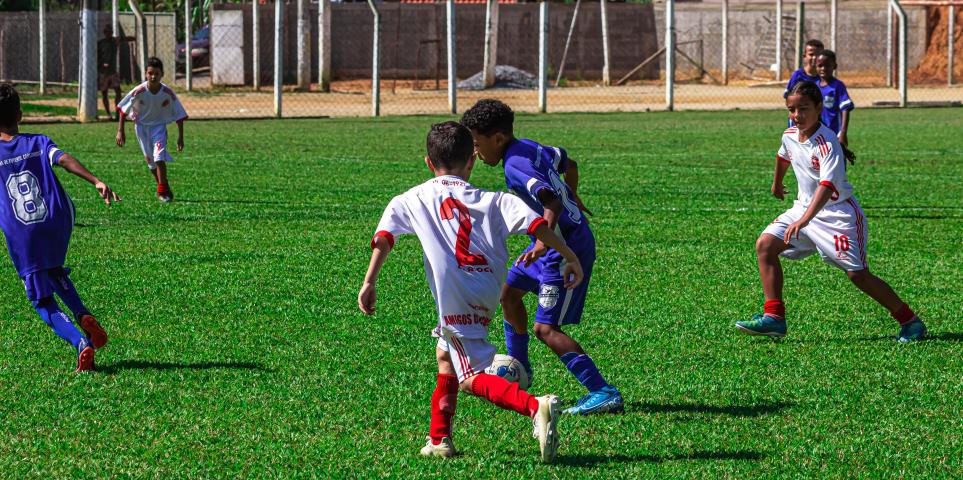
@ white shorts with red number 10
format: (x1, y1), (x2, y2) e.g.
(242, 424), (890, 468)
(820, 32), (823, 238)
(762, 197), (869, 272)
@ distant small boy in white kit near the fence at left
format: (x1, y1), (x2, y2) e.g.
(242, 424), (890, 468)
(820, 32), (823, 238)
(117, 57), (187, 203)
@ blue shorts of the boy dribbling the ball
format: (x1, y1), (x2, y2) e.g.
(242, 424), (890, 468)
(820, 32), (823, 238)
(505, 241), (595, 325)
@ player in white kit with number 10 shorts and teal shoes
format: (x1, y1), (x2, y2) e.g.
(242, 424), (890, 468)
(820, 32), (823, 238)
(736, 81), (926, 342)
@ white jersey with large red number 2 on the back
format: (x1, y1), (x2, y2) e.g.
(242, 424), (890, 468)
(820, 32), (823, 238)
(372, 176), (545, 338)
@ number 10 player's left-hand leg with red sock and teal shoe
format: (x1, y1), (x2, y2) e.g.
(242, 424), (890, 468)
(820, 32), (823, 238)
(736, 233), (789, 338)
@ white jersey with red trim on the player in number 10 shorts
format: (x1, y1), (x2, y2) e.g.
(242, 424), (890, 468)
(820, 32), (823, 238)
(776, 124), (853, 207)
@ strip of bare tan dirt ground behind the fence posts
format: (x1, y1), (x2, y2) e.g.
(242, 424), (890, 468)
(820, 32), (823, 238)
(25, 80), (963, 120)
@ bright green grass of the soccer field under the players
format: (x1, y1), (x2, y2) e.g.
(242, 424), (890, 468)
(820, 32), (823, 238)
(0, 109), (963, 478)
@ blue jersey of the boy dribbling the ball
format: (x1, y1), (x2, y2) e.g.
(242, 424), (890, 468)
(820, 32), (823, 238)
(504, 139), (595, 252)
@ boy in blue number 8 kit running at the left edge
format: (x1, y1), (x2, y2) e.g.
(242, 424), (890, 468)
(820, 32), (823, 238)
(0, 84), (120, 372)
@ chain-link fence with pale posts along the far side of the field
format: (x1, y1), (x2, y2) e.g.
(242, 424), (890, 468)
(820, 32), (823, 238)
(7, 0), (963, 118)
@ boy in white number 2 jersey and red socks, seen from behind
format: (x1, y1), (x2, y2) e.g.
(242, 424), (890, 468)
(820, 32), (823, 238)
(358, 122), (583, 463)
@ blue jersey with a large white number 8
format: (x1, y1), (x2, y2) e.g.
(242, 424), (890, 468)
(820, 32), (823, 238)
(0, 134), (74, 277)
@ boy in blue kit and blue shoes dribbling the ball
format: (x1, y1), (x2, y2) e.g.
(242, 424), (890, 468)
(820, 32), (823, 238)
(461, 99), (623, 414)
